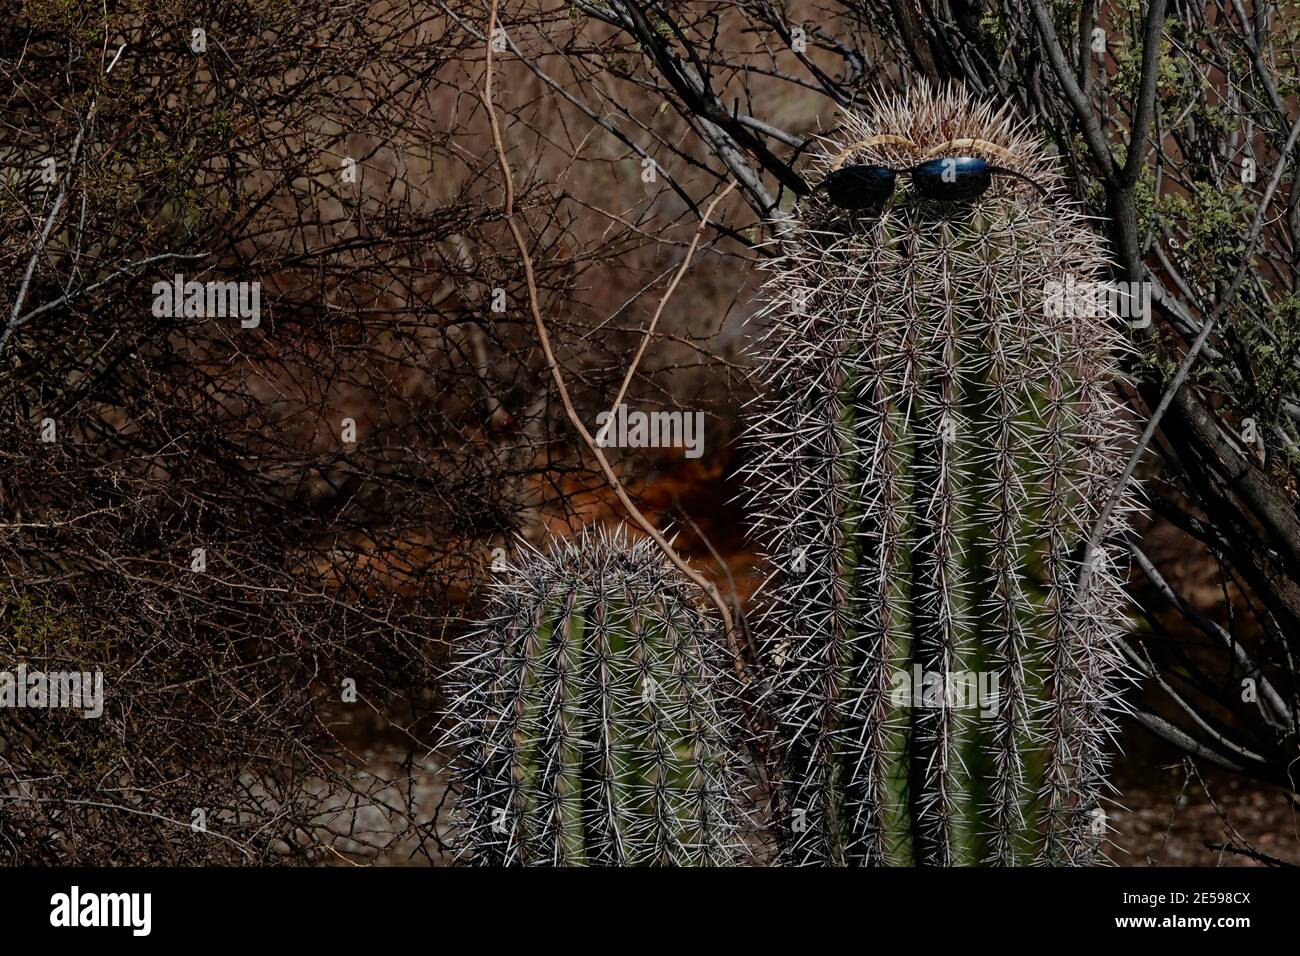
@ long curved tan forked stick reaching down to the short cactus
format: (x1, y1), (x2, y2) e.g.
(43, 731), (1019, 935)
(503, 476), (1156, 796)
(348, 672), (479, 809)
(478, 0), (749, 684)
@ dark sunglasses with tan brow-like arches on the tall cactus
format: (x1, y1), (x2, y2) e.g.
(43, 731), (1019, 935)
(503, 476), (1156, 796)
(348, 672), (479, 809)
(816, 135), (1048, 211)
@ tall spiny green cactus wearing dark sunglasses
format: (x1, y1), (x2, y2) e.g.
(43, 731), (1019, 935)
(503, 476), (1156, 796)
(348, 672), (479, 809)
(746, 90), (1132, 865)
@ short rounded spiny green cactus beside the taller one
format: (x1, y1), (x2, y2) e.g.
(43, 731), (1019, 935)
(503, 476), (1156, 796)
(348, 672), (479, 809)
(441, 532), (740, 866)
